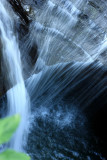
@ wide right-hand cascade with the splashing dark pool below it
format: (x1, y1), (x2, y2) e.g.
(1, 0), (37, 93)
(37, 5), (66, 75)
(23, 0), (107, 160)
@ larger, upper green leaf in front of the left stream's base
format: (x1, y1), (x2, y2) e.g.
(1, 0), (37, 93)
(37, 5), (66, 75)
(0, 115), (20, 144)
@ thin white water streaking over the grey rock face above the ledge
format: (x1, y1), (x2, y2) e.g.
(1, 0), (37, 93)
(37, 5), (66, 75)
(23, 0), (106, 69)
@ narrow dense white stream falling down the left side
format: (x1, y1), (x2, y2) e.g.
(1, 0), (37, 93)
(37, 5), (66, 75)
(0, 0), (29, 151)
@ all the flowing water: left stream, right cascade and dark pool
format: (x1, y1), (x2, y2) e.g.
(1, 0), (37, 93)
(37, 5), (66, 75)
(0, 0), (107, 160)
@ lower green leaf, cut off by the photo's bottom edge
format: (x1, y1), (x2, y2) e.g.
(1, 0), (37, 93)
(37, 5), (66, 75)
(0, 150), (30, 160)
